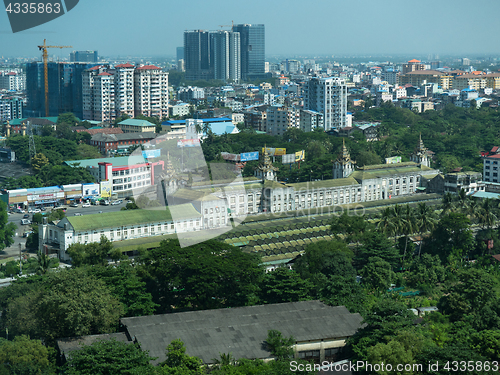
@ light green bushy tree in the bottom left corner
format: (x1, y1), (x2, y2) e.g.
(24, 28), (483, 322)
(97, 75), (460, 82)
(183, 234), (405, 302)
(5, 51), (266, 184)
(0, 336), (56, 375)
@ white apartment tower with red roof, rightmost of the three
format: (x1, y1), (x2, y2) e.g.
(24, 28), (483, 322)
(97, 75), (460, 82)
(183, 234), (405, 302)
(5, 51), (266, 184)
(134, 65), (168, 119)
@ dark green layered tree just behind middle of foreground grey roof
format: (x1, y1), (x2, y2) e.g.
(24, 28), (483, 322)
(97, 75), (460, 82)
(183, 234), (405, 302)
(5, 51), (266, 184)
(259, 267), (313, 303)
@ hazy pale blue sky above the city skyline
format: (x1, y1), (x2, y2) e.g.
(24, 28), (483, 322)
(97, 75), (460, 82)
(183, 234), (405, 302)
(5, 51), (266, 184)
(0, 0), (500, 57)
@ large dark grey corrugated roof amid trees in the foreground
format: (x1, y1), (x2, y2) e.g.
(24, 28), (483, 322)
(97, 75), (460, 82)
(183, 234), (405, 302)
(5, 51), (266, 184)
(121, 301), (363, 363)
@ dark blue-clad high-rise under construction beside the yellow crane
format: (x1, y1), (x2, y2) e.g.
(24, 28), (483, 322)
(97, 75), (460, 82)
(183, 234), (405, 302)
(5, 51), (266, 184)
(24, 62), (97, 118)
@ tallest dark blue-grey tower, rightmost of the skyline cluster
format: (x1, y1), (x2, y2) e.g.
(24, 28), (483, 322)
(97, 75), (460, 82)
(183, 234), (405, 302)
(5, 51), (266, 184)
(233, 24), (266, 80)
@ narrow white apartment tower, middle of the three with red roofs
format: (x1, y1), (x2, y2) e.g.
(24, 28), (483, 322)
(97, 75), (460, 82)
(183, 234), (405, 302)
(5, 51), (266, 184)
(114, 64), (135, 117)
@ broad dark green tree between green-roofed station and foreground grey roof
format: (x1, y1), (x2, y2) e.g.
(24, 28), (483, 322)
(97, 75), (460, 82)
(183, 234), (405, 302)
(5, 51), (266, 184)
(138, 240), (263, 311)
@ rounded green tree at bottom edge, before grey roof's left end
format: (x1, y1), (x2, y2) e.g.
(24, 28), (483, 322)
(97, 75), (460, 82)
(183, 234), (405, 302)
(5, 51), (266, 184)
(64, 338), (156, 375)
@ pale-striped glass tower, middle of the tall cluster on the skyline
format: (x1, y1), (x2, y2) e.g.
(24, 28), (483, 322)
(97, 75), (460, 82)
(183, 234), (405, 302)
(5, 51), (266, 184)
(210, 30), (241, 83)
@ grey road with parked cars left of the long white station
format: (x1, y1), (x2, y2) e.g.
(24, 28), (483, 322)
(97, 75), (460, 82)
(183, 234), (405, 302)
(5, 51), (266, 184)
(0, 201), (126, 259)
